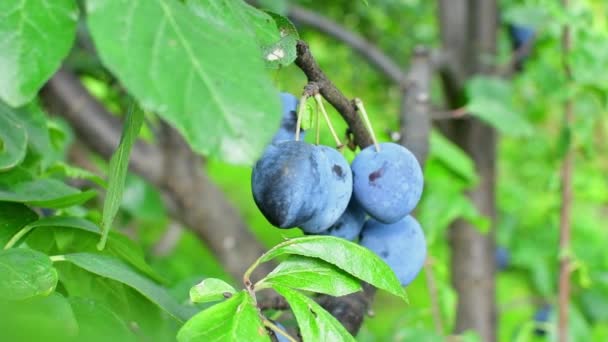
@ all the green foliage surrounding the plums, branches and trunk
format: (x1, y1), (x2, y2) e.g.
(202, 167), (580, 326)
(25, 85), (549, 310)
(0, 0), (608, 341)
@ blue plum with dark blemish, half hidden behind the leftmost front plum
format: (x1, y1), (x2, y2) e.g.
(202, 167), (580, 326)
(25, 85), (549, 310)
(300, 146), (353, 234)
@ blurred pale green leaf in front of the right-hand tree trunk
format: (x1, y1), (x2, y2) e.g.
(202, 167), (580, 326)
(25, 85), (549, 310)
(466, 76), (533, 136)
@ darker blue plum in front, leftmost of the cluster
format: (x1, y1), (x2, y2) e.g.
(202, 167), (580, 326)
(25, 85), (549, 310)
(251, 141), (325, 228)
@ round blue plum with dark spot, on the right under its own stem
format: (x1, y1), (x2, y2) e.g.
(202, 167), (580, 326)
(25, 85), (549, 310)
(351, 143), (424, 223)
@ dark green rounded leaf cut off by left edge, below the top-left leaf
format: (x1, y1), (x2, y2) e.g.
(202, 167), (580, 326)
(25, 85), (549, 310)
(0, 102), (27, 171)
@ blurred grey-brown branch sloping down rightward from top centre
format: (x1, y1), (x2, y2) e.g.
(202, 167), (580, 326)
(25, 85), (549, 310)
(287, 5), (406, 87)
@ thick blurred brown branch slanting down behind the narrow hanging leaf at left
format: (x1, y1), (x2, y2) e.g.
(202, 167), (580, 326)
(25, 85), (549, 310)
(42, 69), (271, 279)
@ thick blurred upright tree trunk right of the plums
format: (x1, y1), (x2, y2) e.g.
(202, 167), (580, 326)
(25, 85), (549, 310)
(439, 0), (498, 341)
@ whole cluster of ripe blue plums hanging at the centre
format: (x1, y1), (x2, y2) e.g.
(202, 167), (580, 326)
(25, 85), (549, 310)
(252, 93), (426, 285)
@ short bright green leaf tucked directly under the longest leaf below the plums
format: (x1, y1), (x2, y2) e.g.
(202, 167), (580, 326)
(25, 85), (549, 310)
(256, 256), (361, 297)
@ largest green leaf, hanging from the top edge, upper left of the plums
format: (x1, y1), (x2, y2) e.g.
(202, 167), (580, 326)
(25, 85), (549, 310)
(87, 0), (280, 163)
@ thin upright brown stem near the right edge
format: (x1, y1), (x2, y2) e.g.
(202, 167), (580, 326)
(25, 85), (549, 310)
(557, 0), (574, 342)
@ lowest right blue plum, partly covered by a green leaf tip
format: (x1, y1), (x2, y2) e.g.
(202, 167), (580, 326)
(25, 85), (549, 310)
(359, 215), (426, 286)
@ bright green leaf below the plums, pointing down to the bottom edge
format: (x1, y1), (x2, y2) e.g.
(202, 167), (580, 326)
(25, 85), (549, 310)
(274, 286), (355, 342)
